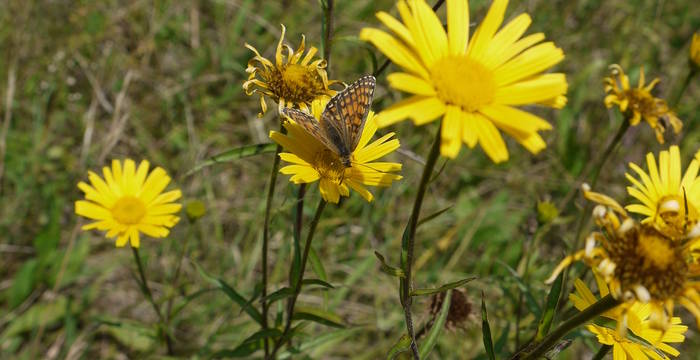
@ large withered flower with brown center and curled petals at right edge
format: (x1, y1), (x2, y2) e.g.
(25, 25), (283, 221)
(547, 186), (700, 330)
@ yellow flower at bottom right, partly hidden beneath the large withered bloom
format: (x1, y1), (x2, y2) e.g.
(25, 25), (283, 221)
(569, 277), (688, 360)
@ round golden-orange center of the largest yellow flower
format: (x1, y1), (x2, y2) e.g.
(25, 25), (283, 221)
(430, 55), (496, 112)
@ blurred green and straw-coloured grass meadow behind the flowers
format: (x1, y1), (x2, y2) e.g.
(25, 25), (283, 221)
(0, 0), (700, 359)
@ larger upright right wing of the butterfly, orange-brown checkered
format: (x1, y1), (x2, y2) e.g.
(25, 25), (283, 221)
(321, 75), (376, 156)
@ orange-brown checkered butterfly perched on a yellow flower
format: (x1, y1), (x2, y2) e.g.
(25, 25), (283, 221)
(282, 75), (377, 167)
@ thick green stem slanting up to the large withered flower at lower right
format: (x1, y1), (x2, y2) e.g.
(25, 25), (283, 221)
(522, 294), (622, 360)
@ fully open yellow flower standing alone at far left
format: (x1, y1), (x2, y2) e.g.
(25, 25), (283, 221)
(75, 159), (182, 248)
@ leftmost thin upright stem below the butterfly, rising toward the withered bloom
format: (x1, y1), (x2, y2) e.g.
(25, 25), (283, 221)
(260, 120), (287, 359)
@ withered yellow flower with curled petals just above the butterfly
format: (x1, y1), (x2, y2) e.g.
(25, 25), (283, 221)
(243, 25), (337, 116)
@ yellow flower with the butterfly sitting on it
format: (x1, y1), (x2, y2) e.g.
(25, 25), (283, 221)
(270, 99), (401, 203)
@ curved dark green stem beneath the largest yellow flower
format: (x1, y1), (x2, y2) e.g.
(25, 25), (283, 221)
(400, 124), (442, 359)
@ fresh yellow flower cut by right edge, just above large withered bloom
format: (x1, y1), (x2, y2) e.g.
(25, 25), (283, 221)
(625, 145), (700, 240)
